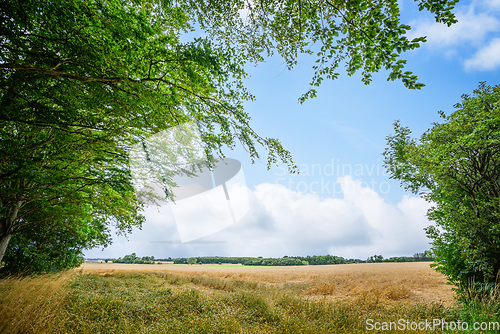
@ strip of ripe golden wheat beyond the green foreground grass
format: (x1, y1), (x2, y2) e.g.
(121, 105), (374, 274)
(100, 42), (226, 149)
(81, 262), (455, 305)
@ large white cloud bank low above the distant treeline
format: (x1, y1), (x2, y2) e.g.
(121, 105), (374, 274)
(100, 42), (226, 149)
(86, 176), (429, 258)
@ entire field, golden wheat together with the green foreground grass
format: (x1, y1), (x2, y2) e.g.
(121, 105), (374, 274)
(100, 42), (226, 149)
(0, 263), (459, 334)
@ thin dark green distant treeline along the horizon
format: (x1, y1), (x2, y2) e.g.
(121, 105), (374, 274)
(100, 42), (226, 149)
(105, 251), (434, 266)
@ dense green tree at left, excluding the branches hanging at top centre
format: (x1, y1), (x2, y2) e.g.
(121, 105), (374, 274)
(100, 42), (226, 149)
(0, 0), (290, 268)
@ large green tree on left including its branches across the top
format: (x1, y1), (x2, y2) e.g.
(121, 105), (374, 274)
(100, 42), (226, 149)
(0, 0), (455, 268)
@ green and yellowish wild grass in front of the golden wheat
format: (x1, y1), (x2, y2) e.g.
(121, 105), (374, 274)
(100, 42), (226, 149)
(0, 268), (499, 333)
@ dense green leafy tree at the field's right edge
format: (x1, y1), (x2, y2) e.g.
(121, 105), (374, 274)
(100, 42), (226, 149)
(384, 83), (500, 287)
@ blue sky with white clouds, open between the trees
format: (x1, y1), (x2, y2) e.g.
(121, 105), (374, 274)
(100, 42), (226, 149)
(85, 0), (500, 259)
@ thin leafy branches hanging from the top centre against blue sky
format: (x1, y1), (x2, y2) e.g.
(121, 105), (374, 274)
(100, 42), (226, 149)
(187, 0), (458, 103)
